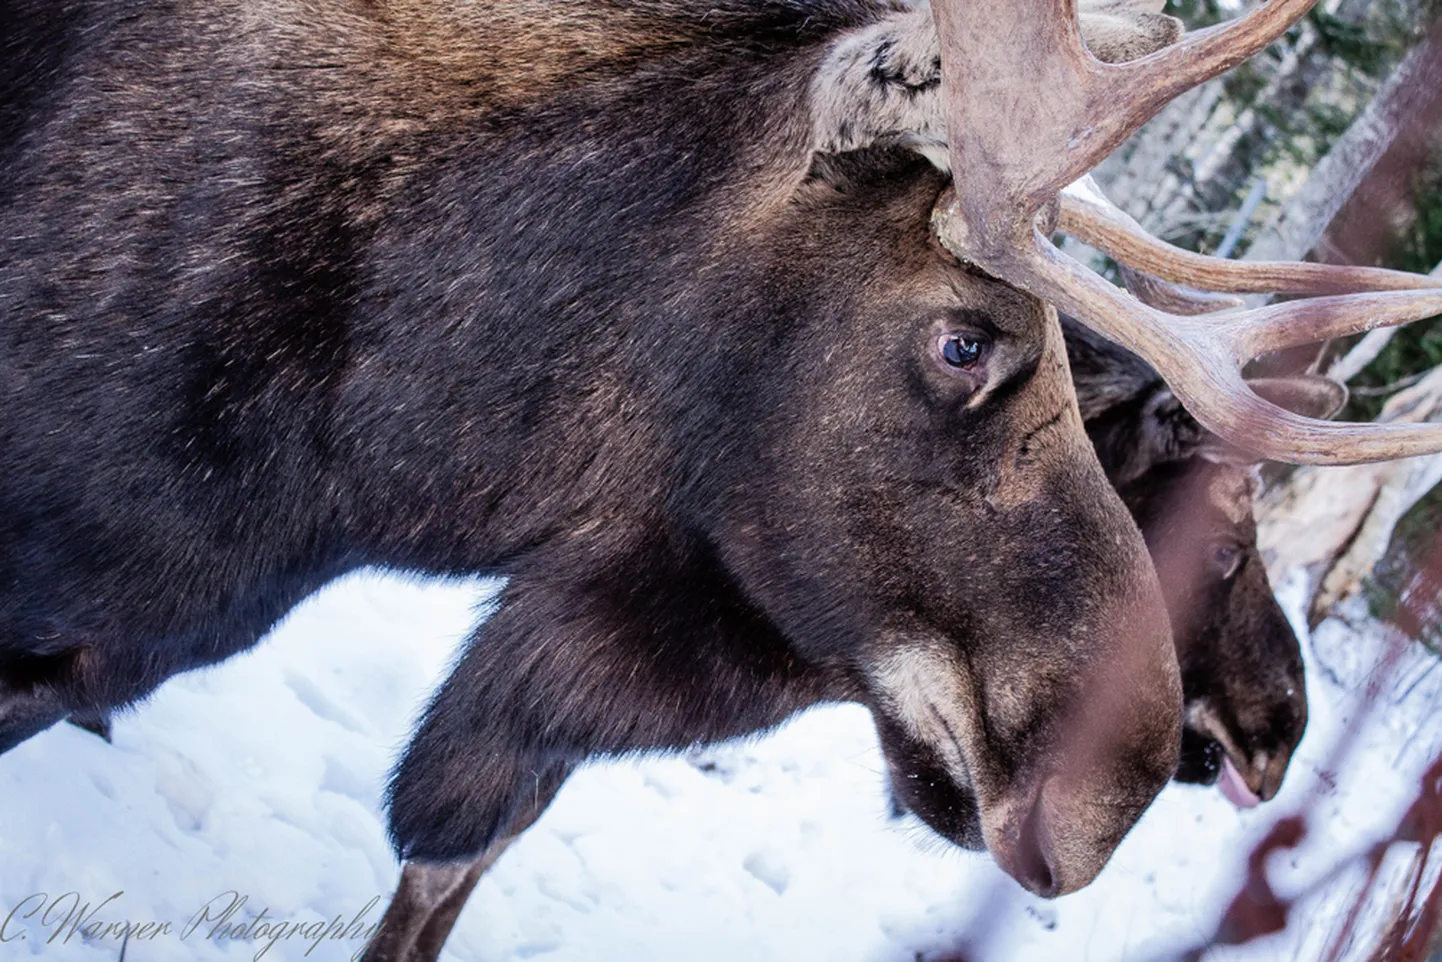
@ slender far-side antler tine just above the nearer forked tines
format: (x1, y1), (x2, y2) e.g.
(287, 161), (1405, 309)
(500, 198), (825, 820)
(1057, 177), (1442, 295)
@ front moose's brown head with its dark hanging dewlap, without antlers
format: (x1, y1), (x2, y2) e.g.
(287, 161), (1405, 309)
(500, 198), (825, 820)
(392, 149), (1181, 896)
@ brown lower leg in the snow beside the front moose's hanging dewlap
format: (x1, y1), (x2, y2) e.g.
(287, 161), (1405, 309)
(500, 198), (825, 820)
(362, 766), (571, 962)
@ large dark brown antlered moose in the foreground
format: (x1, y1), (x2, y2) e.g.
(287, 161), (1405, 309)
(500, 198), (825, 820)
(0, 0), (1442, 959)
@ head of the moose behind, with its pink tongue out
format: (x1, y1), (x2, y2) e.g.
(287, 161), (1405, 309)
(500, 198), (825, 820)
(1061, 320), (1347, 806)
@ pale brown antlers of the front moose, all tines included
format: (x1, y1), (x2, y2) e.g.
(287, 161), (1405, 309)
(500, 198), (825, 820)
(932, 0), (1442, 464)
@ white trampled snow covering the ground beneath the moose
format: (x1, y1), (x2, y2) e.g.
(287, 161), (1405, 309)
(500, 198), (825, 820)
(0, 574), (1442, 962)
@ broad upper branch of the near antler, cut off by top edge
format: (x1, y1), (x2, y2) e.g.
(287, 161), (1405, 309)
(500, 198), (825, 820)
(932, 0), (1315, 242)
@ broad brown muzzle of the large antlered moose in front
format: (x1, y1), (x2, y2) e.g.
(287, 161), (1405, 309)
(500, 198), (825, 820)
(868, 533), (1181, 897)
